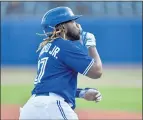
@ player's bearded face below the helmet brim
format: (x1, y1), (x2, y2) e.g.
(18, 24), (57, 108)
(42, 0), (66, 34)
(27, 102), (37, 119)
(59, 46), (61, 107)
(65, 21), (80, 40)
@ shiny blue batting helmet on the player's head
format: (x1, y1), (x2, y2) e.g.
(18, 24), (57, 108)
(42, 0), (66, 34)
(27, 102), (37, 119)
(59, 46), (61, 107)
(41, 7), (82, 33)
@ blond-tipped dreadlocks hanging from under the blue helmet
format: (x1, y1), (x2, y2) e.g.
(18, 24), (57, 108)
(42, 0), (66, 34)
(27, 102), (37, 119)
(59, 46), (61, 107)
(36, 24), (65, 52)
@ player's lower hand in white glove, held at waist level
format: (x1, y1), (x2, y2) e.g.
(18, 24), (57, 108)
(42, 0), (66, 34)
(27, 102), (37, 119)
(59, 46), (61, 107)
(79, 88), (102, 102)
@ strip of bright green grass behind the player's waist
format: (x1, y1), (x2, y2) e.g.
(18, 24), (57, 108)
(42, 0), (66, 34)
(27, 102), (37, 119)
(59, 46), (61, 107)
(1, 85), (142, 112)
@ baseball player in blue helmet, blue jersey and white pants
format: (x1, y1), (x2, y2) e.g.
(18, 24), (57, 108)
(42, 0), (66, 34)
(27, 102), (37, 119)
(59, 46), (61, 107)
(19, 7), (102, 120)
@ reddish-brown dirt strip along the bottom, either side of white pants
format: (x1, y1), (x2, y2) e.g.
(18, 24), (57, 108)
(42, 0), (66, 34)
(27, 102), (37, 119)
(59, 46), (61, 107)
(1, 105), (142, 120)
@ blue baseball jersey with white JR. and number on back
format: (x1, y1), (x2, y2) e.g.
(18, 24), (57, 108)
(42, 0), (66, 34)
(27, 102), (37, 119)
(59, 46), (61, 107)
(32, 38), (94, 109)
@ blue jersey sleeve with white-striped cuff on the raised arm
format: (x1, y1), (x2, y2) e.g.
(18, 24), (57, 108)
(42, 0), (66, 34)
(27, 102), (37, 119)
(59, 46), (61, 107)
(61, 42), (94, 75)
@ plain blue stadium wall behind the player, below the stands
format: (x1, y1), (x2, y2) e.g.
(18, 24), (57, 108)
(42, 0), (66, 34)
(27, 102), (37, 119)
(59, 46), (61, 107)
(1, 16), (142, 65)
